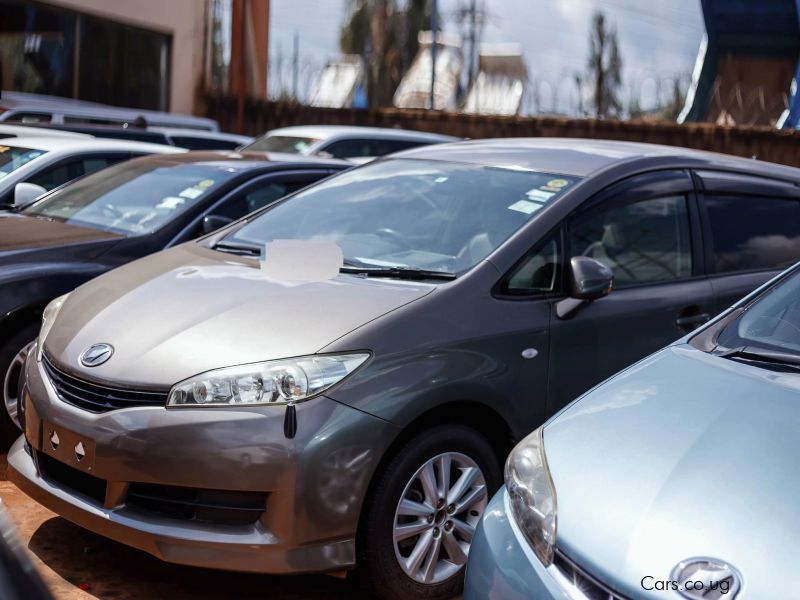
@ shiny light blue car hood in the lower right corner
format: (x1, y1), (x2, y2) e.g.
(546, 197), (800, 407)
(544, 345), (800, 599)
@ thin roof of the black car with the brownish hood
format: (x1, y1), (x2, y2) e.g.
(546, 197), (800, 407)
(131, 150), (353, 172)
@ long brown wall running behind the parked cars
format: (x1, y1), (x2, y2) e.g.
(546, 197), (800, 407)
(206, 96), (800, 167)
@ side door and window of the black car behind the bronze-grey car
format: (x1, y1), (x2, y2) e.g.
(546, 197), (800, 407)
(173, 168), (334, 243)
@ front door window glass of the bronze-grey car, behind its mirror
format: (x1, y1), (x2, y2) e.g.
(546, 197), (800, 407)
(570, 195), (692, 287)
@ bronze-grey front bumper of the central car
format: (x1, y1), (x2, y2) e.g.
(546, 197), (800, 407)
(8, 355), (397, 573)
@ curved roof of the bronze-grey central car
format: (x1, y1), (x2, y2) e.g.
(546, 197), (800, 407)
(392, 137), (800, 180)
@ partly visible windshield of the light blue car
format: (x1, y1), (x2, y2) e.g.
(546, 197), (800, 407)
(718, 273), (800, 355)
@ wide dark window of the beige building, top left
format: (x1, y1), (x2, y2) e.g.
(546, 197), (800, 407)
(0, 0), (170, 110)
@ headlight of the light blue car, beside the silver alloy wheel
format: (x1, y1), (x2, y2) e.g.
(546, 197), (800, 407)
(505, 427), (556, 566)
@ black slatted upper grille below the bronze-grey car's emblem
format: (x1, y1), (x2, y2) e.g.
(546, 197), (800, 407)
(42, 356), (168, 413)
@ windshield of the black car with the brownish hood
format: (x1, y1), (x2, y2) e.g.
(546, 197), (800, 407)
(22, 157), (241, 235)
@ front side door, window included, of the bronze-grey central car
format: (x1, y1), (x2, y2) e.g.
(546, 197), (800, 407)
(548, 171), (713, 414)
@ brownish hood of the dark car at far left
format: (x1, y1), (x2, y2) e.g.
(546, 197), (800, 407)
(0, 212), (122, 257)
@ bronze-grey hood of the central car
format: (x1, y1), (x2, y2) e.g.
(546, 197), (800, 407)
(44, 243), (435, 389)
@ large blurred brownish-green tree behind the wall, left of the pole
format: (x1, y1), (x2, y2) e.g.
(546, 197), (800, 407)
(339, 0), (430, 107)
